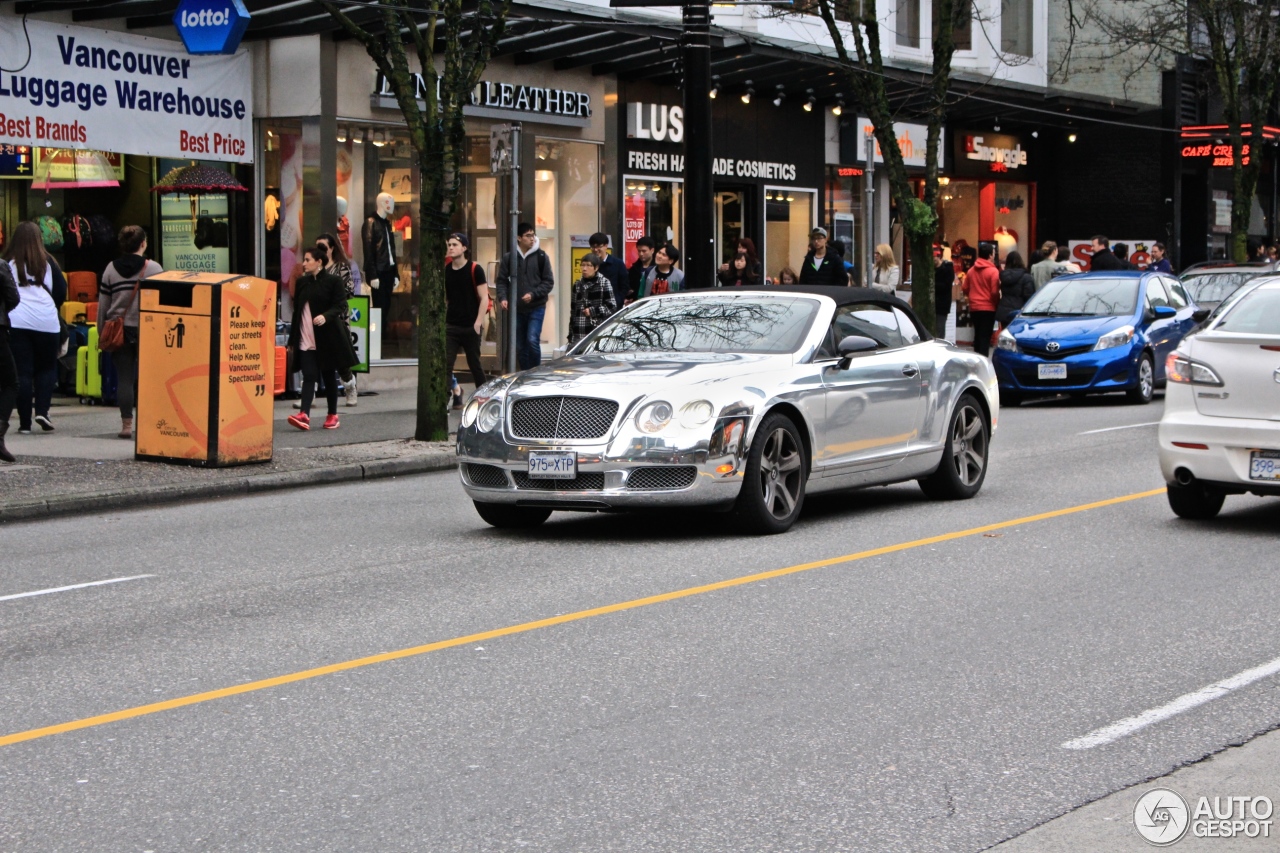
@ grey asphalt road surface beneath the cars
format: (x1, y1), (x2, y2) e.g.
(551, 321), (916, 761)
(0, 400), (1280, 853)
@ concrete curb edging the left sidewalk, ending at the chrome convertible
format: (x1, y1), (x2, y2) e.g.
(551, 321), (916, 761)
(0, 453), (458, 523)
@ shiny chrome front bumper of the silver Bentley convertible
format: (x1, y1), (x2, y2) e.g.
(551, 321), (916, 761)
(458, 418), (749, 511)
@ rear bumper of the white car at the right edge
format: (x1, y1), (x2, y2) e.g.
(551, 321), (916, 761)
(1157, 402), (1280, 496)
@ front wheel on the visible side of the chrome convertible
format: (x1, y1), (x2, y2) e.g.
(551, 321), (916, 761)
(733, 414), (809, 535)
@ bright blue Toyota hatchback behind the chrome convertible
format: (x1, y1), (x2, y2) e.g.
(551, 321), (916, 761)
(992, 272), (1197, 406)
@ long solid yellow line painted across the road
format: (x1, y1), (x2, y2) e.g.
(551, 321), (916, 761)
(0, 488), (1165, 747)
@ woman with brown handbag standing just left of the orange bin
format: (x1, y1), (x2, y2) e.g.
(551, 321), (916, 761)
(97, 225), (164, 438)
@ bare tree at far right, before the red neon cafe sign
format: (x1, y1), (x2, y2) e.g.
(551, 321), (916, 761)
(1082, 0), (1280, 261)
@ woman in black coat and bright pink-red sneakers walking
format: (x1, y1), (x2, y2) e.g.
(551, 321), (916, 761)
(289, 246), (356, 429)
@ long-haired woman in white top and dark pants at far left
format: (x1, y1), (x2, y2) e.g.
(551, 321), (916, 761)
(5, 222), (67, 435)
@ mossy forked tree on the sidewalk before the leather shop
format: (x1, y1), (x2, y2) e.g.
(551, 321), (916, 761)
(312, 0), (511, 441)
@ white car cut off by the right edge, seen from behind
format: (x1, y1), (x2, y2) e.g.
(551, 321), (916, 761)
(1160, 275), (1280, 519)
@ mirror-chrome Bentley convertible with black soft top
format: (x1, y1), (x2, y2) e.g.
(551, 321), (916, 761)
(458, 287), (1000, 533)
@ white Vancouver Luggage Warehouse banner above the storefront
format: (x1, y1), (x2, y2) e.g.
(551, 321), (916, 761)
(0, 18), (253, 163)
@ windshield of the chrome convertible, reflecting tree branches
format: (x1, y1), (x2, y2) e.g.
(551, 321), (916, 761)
(573, 295), (818, 355)
